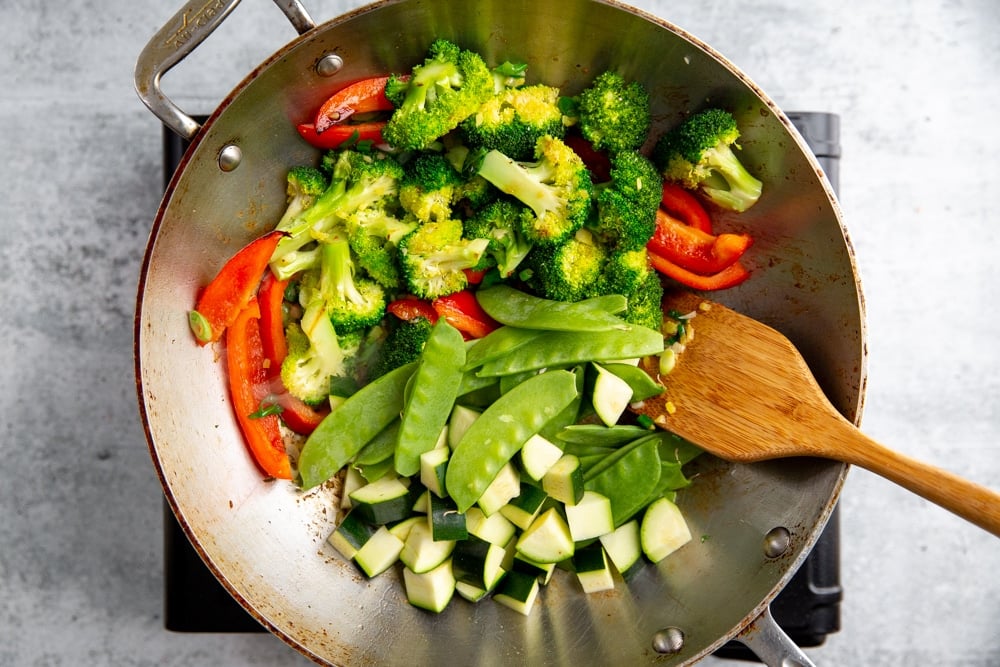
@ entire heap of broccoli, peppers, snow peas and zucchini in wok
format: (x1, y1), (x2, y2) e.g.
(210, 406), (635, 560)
(190, 39), (761, 613)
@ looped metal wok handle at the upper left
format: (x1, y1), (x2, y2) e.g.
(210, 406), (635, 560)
(135, 0), (316, 139)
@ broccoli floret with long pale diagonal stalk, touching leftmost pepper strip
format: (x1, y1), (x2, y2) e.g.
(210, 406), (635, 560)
(271, 150), (403, 279)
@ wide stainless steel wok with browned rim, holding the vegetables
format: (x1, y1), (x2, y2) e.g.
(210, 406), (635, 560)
(135, 0), (865, 665)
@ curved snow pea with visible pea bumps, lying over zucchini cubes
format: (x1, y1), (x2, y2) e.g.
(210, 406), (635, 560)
(445, 370), (577, 512)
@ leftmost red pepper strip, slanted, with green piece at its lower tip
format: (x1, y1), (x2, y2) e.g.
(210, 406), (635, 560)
(188, 231), (285, 345)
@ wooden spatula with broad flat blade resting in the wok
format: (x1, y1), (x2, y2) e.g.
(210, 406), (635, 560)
(635, 294), (1000, 536)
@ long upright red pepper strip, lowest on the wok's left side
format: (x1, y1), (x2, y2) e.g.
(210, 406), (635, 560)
(226, 297), (292, 479)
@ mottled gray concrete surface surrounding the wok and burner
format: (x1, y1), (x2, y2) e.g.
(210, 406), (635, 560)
(0, 0), (1000, 667)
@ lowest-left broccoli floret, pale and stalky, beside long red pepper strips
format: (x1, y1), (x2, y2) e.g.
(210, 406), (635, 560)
(281, 299), (350, 405)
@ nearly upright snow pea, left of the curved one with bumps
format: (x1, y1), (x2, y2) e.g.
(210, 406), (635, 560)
(395, 317), (465, 477)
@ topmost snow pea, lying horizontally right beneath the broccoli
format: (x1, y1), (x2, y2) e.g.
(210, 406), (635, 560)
(476, 285), (628, 331)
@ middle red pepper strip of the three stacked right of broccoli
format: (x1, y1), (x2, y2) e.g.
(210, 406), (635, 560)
(646, 208), (753, 276)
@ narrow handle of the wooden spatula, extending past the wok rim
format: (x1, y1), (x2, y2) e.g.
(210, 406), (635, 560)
(838, 426), (1000, 537)
